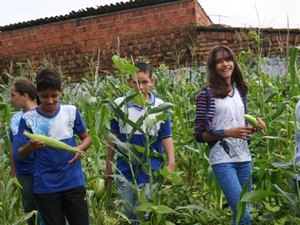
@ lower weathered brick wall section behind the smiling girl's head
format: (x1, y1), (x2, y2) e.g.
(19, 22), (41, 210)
(194, 26), (300, 62)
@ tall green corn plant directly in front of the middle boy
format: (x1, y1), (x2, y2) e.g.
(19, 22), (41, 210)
(102, 57), (183, 224)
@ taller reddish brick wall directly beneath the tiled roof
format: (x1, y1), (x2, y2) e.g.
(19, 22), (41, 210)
(0, 0), (211, 80)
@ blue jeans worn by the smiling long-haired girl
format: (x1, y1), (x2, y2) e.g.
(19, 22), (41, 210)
(212, 162), (252, 225)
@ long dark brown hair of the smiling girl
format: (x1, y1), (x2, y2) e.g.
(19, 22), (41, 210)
(207, 45), (249, 98)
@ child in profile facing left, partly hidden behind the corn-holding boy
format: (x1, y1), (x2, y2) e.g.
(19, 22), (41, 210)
(9, 78), (43, 225)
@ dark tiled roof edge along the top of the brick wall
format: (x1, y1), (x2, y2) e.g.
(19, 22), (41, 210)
(0, 0), (190, 32)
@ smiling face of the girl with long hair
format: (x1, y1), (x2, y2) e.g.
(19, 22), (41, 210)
(216, 51), (234, 80)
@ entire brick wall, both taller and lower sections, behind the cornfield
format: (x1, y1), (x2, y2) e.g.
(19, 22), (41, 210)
(0, 0), (299, 81)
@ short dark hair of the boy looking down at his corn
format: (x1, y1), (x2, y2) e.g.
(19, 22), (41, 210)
(35, 68), (61, 92)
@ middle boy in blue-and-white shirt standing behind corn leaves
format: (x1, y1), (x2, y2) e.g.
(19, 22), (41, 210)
(105, 61), (175, 223)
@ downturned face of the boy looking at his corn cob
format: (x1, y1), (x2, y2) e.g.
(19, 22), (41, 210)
(38, 89), (62, 114)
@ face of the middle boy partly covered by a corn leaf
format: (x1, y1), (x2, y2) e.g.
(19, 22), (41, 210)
(128, 72), (155, 97)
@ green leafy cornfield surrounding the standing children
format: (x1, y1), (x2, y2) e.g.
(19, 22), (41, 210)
(0, 45), (300, 225)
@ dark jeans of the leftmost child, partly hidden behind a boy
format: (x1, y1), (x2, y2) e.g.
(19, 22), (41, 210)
(17, 173), (44, 225)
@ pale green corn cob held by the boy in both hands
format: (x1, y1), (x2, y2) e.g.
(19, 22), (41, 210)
(23, 131), (84, 154)
